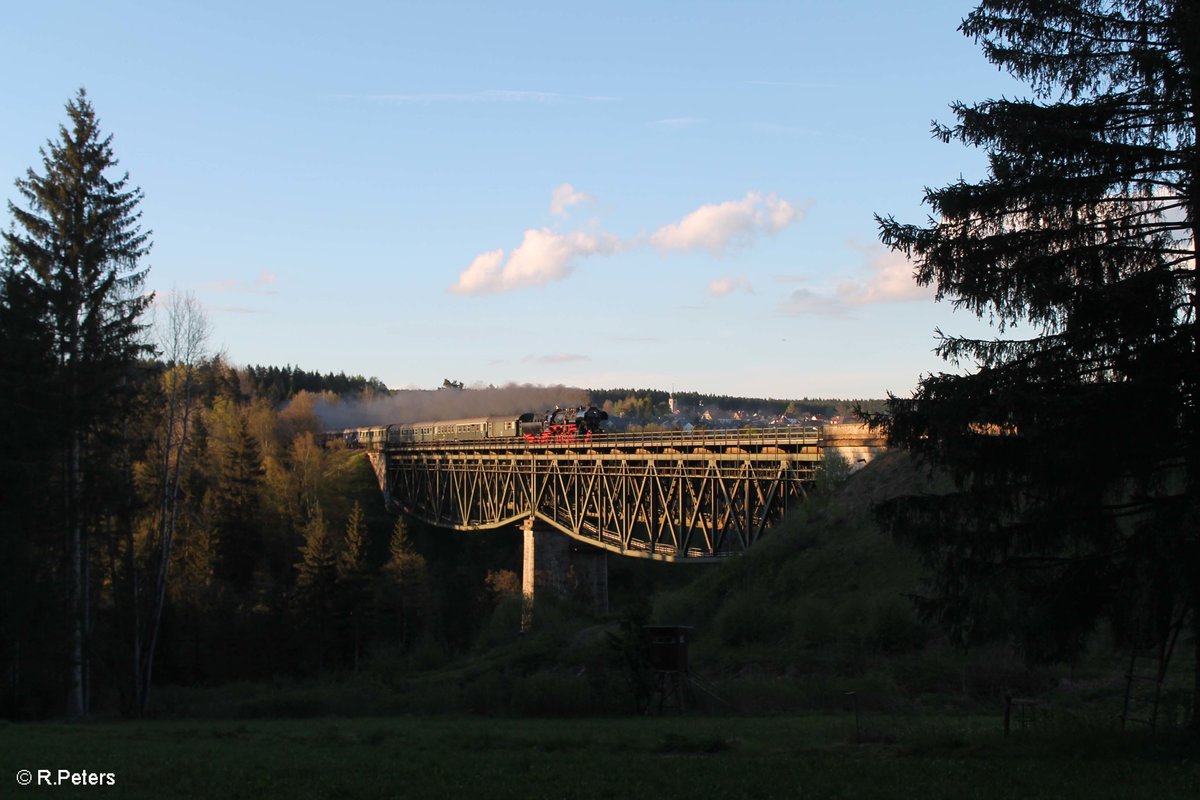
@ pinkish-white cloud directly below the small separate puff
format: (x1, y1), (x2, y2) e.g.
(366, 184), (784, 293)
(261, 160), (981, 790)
(450, 228), (619, 294)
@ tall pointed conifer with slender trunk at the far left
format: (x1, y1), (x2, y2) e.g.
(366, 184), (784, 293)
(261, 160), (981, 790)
(4, 89), (151, 717)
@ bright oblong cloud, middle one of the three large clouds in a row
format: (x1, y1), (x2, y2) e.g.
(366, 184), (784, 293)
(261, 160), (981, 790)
(650, 192), (803, 255)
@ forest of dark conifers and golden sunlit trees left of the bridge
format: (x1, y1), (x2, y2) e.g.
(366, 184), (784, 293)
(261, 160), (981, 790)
(0, 90), (511, 718)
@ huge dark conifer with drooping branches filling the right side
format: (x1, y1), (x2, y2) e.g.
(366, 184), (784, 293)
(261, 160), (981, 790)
(875, 0), (1200, 720)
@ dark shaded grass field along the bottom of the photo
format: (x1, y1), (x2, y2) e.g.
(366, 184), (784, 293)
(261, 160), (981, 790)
(0, 715), (1200, 800)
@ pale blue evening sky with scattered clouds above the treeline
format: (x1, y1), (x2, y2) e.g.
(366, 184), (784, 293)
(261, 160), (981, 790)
(0, 0), (1027, 398)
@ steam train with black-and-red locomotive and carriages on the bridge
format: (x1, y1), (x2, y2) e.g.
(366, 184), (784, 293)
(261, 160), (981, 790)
(325, 405), (608, 447)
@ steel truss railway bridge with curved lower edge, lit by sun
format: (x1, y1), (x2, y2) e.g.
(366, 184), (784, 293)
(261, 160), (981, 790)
(367, 427), (823, 561)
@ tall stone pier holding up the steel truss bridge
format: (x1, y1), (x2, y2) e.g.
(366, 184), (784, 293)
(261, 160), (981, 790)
(521, 518), (608, 628)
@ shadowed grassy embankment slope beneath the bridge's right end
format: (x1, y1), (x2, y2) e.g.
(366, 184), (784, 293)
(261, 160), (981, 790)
(654, 453), (929, 670)
